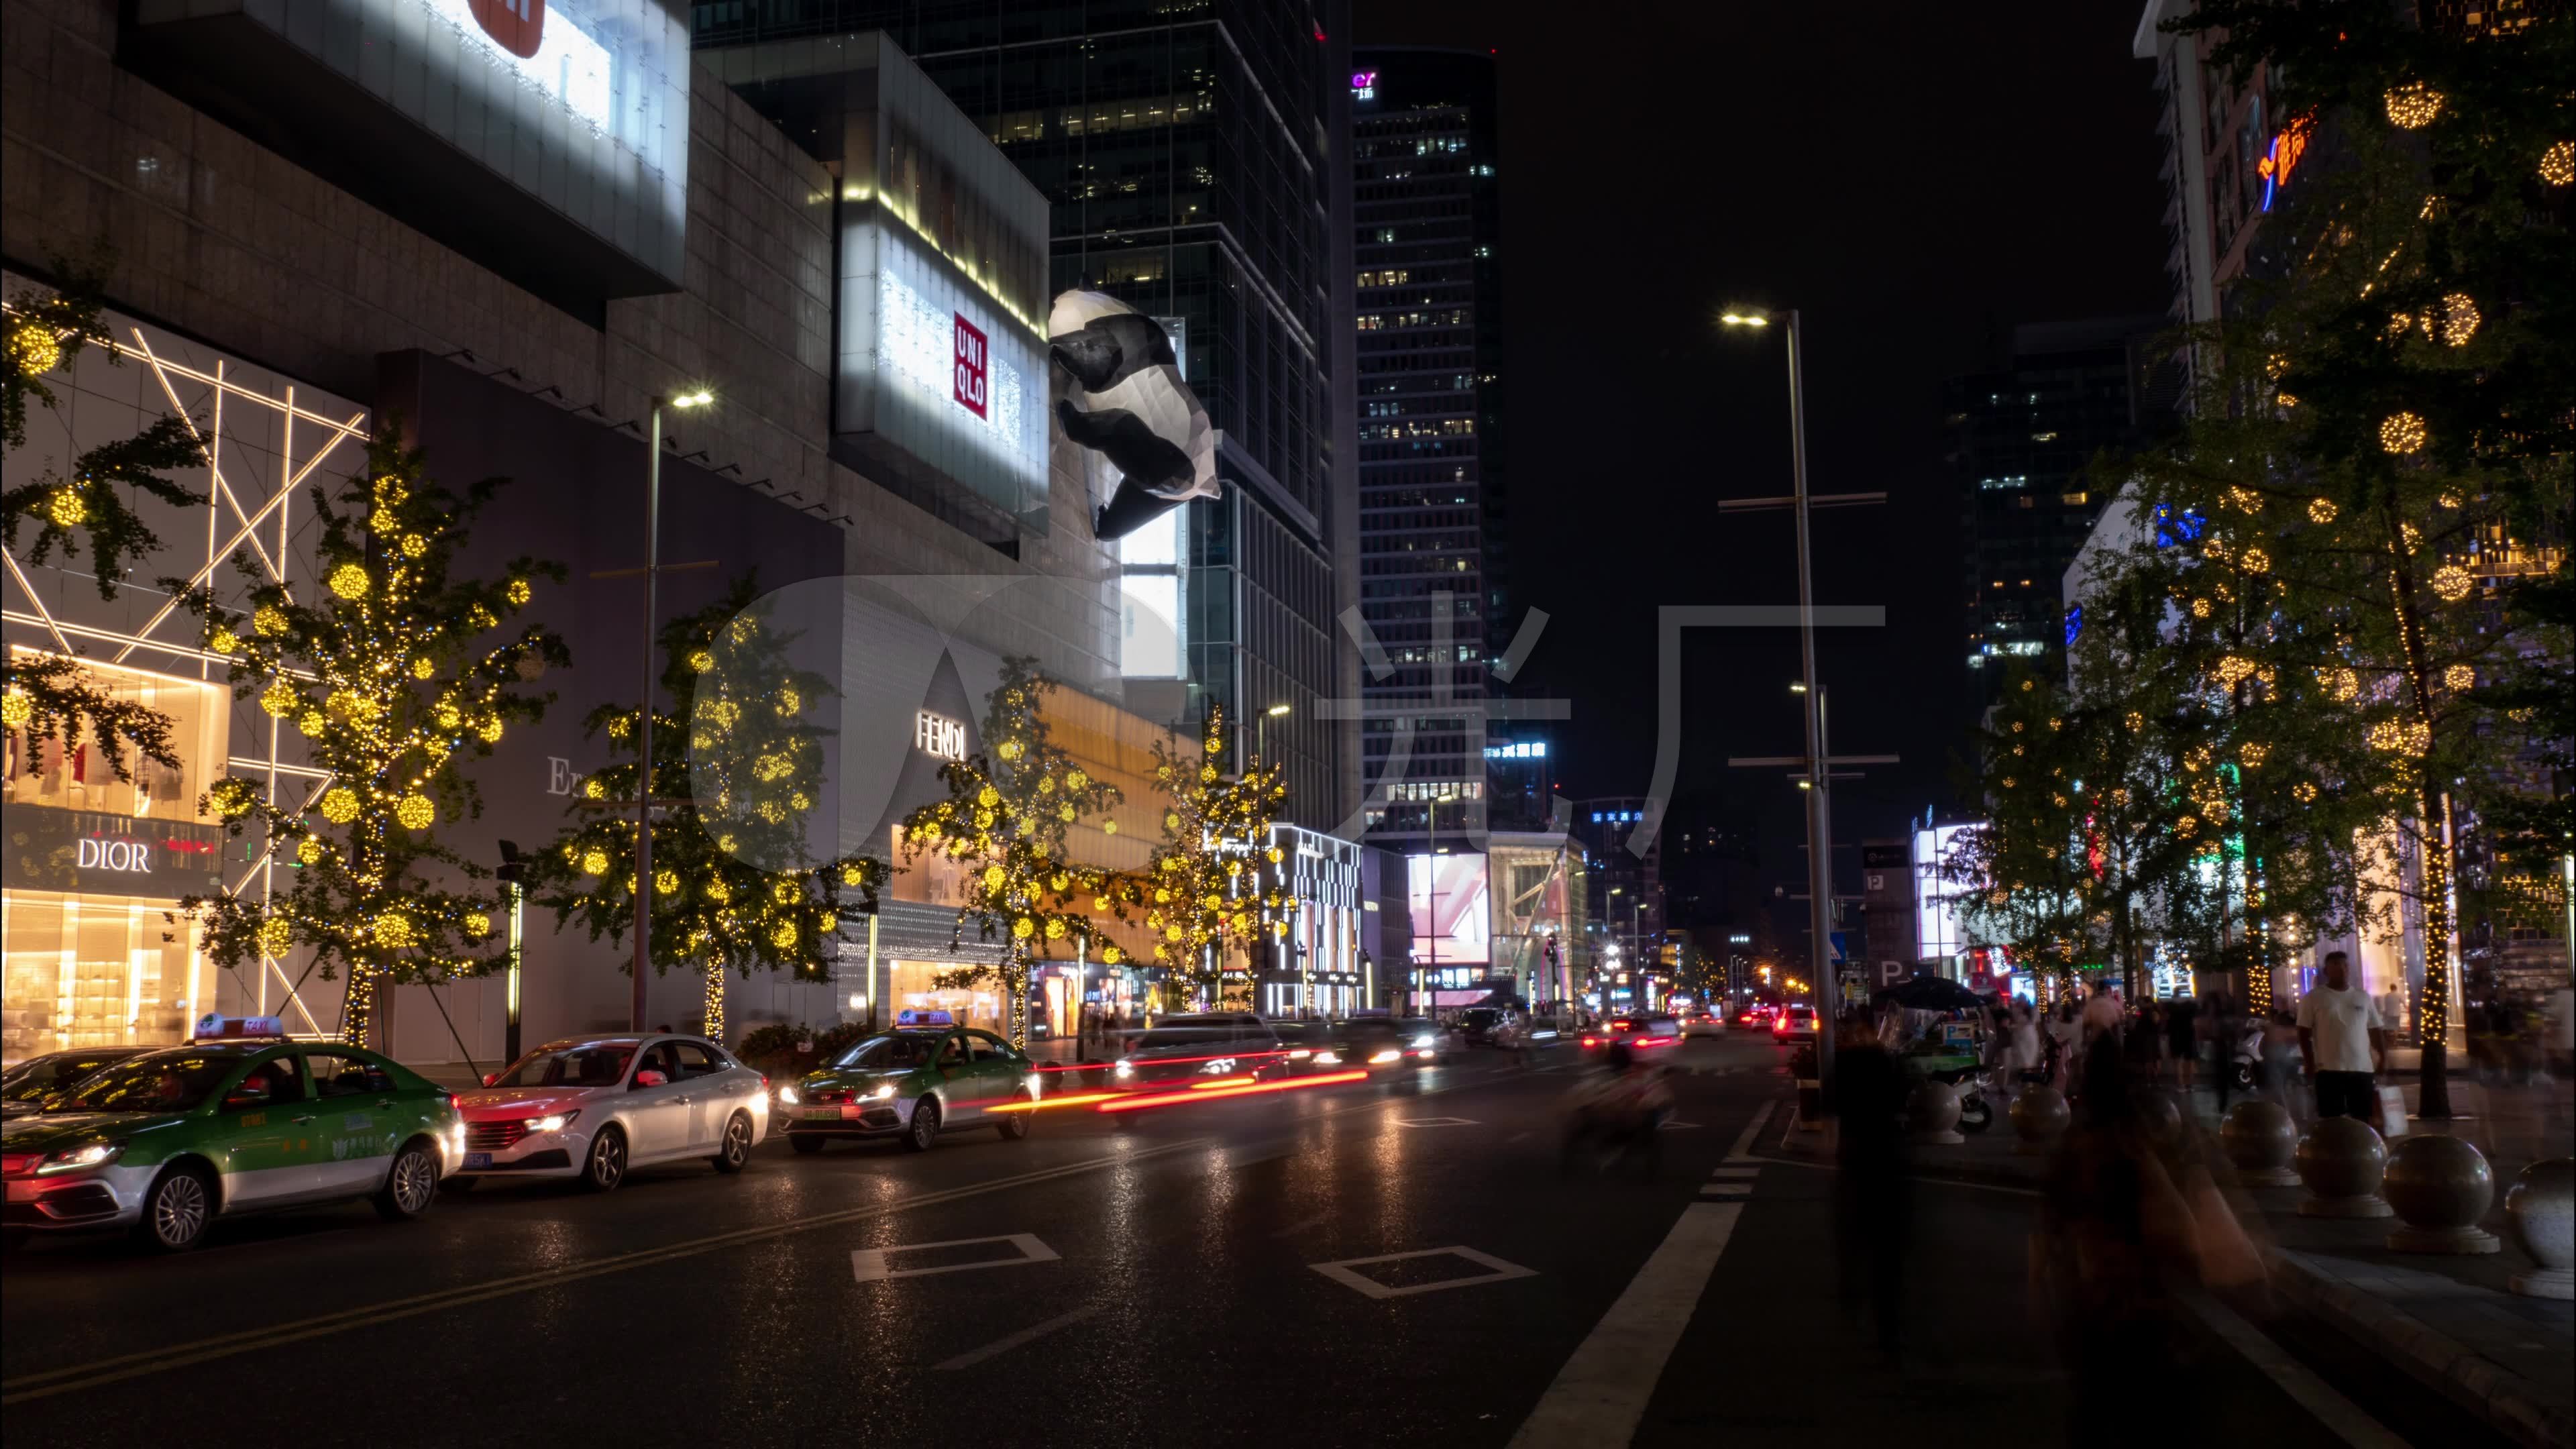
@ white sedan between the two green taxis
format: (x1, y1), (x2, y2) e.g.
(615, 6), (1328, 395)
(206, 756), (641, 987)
(448, 1036), (770, 1191)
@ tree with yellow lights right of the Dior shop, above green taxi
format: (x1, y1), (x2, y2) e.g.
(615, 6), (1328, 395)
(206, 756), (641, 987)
(180, 425), (572, 1044)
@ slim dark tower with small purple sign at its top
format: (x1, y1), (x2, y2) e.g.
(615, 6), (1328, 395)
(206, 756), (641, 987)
(1350, 46), (1504, 848)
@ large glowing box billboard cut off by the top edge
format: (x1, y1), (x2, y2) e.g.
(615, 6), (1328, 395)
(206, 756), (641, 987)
(119, 0), (688, 317)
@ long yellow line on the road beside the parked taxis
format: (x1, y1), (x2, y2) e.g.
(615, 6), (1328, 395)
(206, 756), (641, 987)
(0, 1137), (1211, 1408)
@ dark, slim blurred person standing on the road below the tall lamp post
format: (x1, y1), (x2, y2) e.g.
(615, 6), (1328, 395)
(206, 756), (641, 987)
(1834, 1016), (1914, 1366)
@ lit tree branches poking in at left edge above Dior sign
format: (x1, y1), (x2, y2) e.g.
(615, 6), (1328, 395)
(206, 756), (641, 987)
(0, 258), (206, 779)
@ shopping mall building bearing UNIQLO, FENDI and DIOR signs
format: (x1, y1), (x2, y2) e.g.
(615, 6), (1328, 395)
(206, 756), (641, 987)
(0, 0), (1376, 1062)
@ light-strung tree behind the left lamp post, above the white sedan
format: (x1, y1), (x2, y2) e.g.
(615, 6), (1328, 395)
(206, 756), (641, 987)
(531, 578), (886, 1039)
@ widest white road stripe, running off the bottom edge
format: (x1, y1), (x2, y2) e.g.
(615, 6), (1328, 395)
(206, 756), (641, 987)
(1512, 1201), (1744, 1449)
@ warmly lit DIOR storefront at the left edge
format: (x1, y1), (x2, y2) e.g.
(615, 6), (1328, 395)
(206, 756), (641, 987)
(0, 663), (229, 1062)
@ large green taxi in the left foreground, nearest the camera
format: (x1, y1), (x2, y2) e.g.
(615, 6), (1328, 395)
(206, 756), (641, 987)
(0, 1039), (464, 1253)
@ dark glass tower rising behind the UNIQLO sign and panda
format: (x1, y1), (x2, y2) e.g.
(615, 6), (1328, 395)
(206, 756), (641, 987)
(693, 0), (1358, 830)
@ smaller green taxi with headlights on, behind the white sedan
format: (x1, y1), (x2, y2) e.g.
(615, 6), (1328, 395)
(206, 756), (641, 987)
(778, 1011), (1038, 1152)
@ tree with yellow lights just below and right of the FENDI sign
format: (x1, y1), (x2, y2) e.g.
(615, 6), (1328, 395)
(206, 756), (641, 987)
(904, 657), (1131, 1046)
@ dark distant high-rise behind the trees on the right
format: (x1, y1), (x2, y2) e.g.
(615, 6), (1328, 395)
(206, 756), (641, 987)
(1947, 317), (2169, 712)
